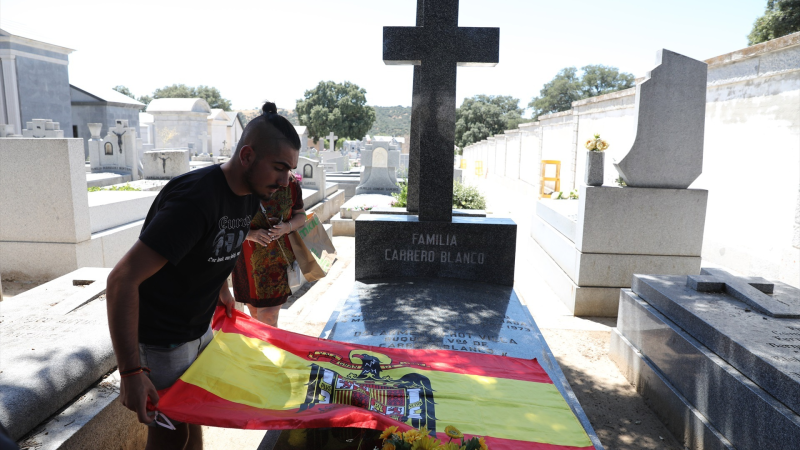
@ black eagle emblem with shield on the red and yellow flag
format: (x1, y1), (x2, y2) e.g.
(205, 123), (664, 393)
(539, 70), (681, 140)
(298, 350), (436, 433)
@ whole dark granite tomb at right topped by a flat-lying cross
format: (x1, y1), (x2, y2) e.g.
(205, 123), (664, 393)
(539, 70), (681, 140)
(610, 269), (800, 449)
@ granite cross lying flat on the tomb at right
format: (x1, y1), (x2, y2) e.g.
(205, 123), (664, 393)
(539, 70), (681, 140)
(686, 268), (800, 318)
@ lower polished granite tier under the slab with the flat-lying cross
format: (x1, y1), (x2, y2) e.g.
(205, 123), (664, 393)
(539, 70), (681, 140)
(617, 289), (800, 449)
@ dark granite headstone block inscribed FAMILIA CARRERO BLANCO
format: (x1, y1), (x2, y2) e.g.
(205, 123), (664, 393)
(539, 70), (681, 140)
(355, 214), (517, 286)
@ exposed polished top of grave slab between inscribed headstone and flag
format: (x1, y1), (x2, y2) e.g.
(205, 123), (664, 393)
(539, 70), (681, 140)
(259, 280), (603, 450)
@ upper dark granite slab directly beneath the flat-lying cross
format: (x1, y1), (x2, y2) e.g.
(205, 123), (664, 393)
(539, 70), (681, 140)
(632, 275), (800, 413)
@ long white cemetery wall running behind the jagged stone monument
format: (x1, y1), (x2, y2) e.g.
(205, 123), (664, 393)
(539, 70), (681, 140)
(464, 33), (800, 286)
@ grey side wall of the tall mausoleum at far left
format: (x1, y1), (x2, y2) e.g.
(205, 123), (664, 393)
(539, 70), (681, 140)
(16, 56), (72, 136)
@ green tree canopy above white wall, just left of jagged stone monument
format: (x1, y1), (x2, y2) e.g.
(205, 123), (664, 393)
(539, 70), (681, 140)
(528, 64), (635, 117)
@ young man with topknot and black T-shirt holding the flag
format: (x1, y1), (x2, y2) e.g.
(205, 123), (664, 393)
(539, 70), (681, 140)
(106, 103), (300, 450)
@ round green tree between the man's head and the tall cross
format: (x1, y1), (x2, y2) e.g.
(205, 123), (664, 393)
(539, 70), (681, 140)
(295, 81), (375, 142)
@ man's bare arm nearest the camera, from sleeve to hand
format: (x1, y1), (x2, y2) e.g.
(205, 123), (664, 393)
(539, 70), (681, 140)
(106, 240), (167, 423)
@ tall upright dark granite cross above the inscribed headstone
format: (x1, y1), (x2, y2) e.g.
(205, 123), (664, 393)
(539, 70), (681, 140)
(383, 0), (500, 222)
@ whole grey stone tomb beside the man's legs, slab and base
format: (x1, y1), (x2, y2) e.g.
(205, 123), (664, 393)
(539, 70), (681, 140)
(0, 268), (146, 448)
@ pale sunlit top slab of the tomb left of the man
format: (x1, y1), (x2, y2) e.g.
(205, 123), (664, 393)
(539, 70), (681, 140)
(0, 268), (116, 439)
